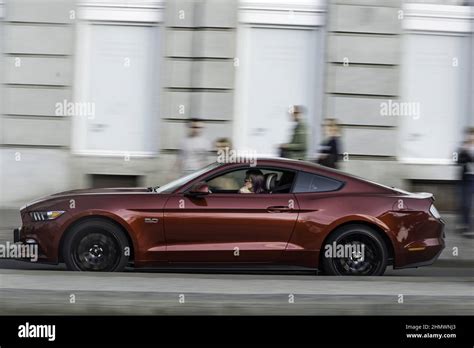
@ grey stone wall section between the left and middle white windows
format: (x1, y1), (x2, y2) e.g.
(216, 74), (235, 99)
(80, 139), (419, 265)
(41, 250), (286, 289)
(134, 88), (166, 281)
(160, 0), (237, 177)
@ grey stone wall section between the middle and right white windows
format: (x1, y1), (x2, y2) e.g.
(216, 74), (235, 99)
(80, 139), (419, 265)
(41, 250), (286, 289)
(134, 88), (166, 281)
(325, 0), (403, 186)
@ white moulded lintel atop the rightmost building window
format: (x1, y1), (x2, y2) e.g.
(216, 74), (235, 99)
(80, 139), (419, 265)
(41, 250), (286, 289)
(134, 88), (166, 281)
(403, 4), (474, 33)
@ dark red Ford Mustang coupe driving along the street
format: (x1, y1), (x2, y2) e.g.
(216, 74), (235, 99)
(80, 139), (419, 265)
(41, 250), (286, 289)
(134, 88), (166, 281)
(14, 158), (445, 276)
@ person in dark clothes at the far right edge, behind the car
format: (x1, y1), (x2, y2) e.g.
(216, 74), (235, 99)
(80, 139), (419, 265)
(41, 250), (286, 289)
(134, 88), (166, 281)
(458, 127), (474, 233)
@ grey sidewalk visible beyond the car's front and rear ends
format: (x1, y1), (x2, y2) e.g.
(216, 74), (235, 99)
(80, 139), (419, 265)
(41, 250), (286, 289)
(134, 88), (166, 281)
(0, 209), (474, 267)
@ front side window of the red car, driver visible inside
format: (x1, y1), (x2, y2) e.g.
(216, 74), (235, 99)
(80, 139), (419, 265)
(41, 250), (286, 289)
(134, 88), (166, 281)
(206, 167), (295, 193)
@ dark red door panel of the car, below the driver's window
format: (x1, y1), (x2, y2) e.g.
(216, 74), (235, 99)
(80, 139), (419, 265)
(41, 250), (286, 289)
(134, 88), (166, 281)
(164, 167), (299, 263)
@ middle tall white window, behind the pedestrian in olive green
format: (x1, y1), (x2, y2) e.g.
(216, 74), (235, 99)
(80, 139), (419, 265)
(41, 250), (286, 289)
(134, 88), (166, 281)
(234, 1), (324, 155)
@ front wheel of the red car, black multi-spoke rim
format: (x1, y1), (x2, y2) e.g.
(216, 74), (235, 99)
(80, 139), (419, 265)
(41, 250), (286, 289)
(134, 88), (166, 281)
(62, 218), (130, 272)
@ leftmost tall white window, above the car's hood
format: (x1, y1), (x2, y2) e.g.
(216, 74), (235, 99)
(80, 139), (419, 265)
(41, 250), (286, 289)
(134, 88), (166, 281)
(73, 3), (160, 156)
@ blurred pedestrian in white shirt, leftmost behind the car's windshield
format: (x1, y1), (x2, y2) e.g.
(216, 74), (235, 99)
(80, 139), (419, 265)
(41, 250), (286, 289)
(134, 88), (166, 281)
(179, 118), (211, 175)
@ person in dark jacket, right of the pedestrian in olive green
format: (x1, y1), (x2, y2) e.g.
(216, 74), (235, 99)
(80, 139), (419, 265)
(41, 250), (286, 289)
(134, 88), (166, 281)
(317, 118), (340, 168)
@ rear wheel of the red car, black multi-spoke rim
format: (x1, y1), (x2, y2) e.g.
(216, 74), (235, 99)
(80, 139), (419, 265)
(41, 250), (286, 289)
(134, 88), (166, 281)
(321, 224), (388, 276)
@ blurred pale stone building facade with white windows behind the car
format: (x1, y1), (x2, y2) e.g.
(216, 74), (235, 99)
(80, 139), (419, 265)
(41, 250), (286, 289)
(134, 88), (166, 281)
(0, 0), (474, 210)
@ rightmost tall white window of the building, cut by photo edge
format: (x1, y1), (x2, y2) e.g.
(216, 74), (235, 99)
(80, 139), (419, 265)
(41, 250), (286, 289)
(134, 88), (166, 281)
(398, 4), (472, 164)
